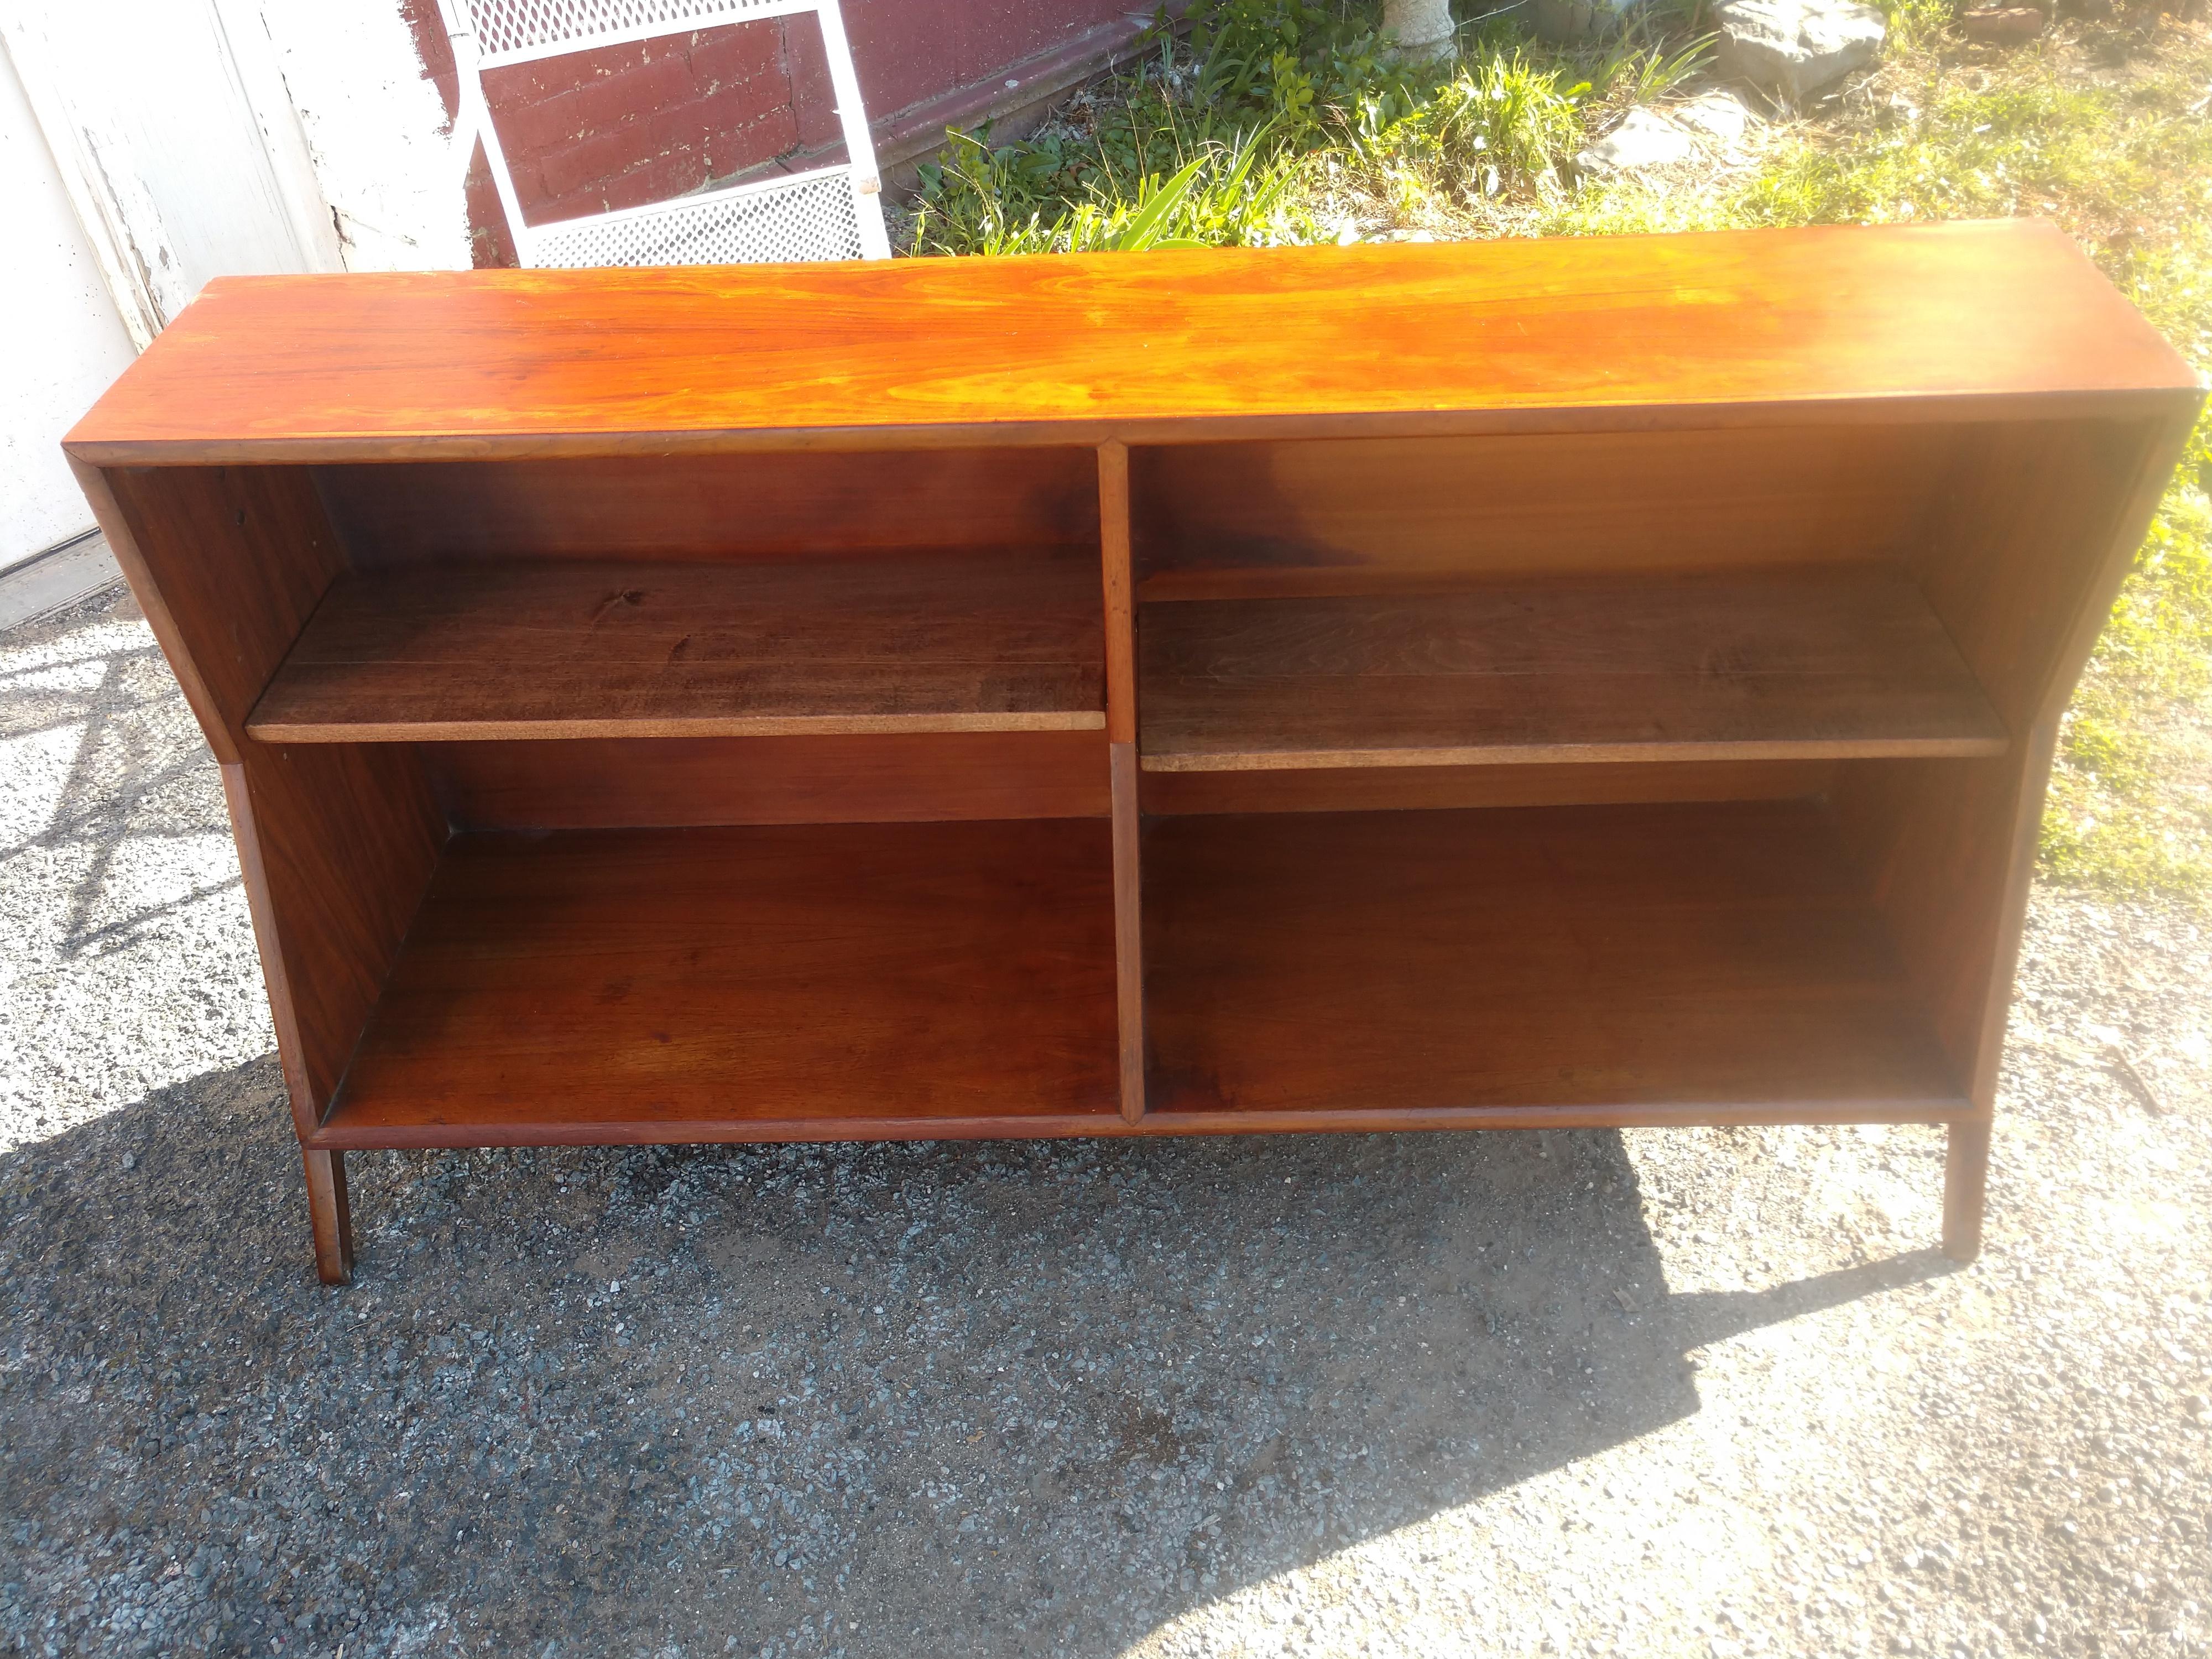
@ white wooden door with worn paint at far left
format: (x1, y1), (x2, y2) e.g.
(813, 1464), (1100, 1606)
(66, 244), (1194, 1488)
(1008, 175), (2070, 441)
(0, 0), (341, 568)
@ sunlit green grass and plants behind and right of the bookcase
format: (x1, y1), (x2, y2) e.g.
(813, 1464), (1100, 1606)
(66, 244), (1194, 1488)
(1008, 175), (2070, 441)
(911, 0), (2212, 902)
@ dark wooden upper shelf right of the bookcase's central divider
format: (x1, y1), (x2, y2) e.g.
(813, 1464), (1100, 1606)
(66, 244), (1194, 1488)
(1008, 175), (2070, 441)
(1137, 564), (2006, 772)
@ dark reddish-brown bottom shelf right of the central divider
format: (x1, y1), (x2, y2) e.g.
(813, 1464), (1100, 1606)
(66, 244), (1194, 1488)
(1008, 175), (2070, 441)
(1144, 801), (1971, 1133)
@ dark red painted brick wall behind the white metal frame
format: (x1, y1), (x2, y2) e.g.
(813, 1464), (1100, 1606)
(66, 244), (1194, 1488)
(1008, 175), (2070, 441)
(400, 0), (1150, 265)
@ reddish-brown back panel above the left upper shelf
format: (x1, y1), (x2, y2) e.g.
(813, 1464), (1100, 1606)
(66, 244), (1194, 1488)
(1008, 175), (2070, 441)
(316, 449), (1097, 564)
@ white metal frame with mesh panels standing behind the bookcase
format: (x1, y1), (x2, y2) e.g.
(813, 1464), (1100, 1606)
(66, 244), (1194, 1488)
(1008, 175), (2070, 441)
(438, 0), (891, 265)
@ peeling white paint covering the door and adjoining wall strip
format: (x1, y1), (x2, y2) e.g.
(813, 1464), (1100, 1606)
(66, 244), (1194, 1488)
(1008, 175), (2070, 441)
(0, 0), (469, 566)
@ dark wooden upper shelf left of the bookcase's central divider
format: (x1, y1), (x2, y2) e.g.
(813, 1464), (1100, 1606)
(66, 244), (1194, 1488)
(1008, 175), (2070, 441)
(246, 553), (1106, 743)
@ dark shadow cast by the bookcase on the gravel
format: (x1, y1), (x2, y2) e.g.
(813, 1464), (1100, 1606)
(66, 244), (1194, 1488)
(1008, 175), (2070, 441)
(0, 1055), (1942, 1655)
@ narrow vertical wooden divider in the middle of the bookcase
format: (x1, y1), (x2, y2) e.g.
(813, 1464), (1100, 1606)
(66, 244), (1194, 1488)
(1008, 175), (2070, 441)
(1099, 442), (1144, 1124)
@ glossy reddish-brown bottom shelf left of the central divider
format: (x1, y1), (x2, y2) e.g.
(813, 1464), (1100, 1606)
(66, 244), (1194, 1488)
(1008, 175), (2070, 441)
(314, 818), (1121, 1146)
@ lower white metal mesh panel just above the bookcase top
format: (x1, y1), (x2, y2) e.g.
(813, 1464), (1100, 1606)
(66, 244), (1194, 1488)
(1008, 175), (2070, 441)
(531, 173), (863, 268)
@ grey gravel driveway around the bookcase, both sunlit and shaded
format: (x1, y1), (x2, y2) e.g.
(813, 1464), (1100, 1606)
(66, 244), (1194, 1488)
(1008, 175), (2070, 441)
(0, 597), (2212, 1659)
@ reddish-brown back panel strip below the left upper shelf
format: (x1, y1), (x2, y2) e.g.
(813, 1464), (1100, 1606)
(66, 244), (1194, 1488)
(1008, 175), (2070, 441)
(420, 732), (1113, 830)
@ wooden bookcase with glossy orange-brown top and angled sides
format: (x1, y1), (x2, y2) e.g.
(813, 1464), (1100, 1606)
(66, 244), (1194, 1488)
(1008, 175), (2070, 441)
(66, 223), (2201, 1281)
